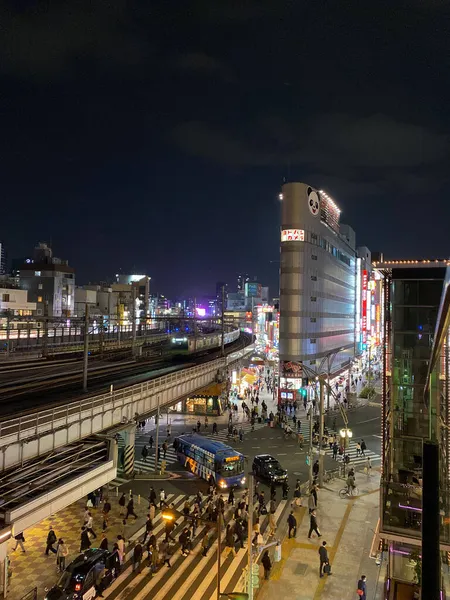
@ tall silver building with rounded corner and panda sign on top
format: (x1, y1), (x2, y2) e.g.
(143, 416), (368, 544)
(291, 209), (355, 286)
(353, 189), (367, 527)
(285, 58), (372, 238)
(279, 183), (356, 378)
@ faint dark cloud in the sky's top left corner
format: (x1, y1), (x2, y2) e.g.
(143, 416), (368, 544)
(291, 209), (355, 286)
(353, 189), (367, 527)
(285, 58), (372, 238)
(0, 0), (148, 78)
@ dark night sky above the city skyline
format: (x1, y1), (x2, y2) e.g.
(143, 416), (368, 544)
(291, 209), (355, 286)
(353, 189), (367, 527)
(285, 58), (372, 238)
(0, 0), (450, 296)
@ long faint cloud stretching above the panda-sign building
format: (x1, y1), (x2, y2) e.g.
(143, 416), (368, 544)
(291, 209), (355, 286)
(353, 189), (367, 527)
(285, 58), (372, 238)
(174, 114), (449, 170)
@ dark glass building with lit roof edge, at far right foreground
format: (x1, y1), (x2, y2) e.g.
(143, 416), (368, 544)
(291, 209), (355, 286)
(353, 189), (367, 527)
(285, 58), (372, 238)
(373, 260), (450, 599)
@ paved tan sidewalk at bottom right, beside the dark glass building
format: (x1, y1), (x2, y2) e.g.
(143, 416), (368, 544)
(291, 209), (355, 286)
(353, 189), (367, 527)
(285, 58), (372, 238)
(257, 472), (384, 600)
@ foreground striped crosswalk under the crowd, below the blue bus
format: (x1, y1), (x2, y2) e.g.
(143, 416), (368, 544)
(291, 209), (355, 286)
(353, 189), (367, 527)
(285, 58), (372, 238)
(103, 494), (286, 600)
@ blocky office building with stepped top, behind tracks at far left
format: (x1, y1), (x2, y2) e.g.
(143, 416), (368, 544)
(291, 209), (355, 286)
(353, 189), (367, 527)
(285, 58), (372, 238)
(19, 242), (75, 317)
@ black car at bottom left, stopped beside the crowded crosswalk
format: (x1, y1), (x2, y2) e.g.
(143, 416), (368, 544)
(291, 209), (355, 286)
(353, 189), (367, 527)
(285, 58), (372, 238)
(45, 548), (120, 600)
